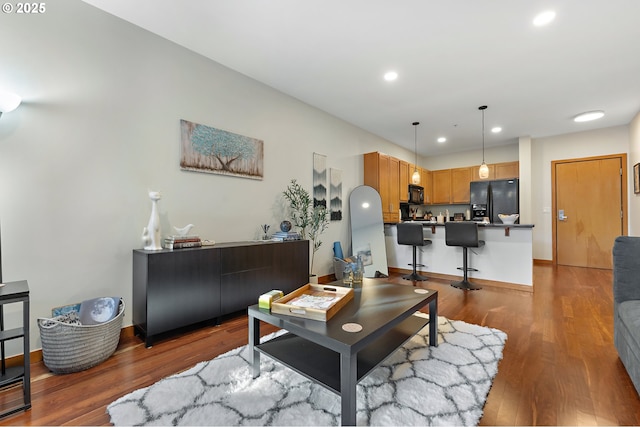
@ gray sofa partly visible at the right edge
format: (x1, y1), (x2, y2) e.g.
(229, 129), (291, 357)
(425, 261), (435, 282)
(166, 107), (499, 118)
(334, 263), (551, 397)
(613, 236), (640, 394)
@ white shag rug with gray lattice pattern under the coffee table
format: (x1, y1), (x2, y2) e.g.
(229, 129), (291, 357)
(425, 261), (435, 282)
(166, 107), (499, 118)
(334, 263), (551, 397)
(107, 313), (507, 426)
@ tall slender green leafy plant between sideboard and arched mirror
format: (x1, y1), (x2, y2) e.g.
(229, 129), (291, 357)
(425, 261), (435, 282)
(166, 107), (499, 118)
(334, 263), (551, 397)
(282, 179), (329, 275)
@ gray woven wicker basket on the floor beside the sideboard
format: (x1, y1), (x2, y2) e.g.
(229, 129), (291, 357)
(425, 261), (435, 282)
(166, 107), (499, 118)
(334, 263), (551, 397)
(38, 299), (124, 374)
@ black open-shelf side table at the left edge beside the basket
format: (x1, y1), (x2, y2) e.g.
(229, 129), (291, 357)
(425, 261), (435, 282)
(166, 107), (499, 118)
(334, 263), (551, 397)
(0, 280), (31, 418)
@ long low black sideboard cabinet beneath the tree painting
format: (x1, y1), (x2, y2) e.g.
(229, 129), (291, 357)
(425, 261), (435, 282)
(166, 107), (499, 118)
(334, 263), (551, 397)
(133, 240), (309, 347)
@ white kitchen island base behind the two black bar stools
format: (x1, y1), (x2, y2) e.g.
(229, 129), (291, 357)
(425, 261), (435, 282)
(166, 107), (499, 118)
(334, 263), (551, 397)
(385, 221), (534, 291)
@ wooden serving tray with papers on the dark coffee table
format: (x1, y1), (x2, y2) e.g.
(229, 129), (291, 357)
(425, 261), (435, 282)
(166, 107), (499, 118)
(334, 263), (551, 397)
(271, 283), (353, 322)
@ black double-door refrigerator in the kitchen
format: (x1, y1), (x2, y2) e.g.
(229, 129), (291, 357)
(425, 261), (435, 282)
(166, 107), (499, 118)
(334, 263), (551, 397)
(471, 178), (520, 224)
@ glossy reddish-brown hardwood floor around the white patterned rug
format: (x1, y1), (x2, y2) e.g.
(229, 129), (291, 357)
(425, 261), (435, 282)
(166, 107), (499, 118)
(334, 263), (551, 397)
(0, 265), (640, 425)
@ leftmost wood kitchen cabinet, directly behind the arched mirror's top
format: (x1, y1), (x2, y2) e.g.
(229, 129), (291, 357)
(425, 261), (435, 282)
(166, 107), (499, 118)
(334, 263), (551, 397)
(364, 152), (400, 223)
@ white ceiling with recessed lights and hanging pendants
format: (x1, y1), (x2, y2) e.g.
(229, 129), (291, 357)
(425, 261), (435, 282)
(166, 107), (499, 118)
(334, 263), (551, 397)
(85, 0), (640, 156)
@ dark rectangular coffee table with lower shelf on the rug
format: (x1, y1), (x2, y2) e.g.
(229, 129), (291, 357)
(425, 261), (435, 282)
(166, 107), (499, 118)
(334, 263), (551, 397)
(248, 279), (438, 425)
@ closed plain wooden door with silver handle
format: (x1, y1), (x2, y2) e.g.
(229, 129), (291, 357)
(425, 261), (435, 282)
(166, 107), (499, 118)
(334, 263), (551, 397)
(552, 154), (627, 269)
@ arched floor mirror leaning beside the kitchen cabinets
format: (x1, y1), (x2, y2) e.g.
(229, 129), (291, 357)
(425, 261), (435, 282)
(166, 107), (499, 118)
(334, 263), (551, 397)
(349, 185), (389, 277)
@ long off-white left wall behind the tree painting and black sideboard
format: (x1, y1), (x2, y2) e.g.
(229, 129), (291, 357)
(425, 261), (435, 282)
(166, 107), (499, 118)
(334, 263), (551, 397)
(0, 0), (413, 354)
